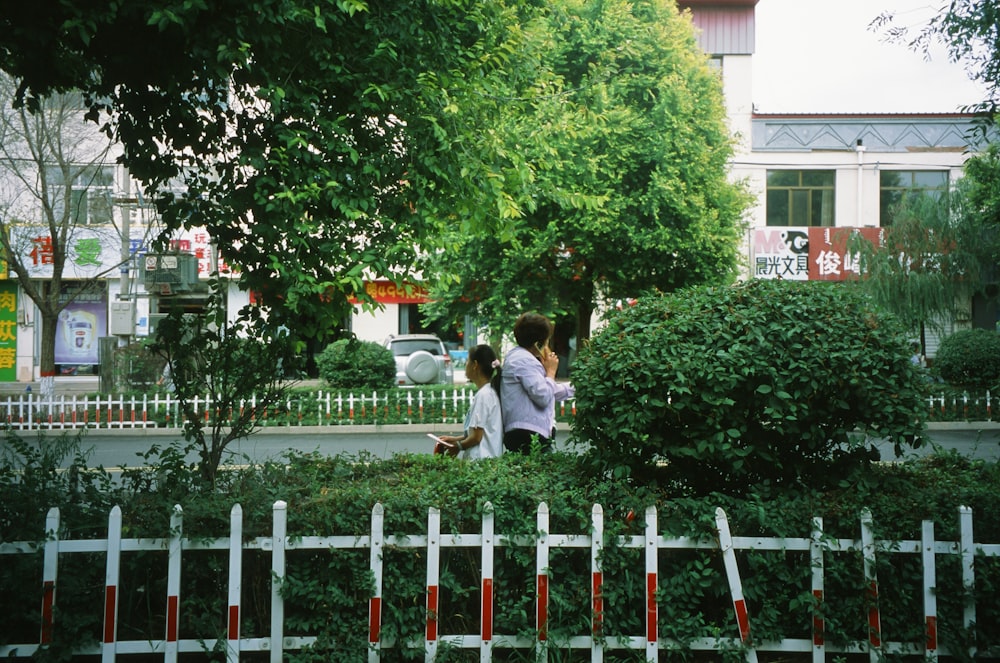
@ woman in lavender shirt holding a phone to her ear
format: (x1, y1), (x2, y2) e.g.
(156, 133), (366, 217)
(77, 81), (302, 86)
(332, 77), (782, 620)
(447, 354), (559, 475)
(500, 313), (573, 453)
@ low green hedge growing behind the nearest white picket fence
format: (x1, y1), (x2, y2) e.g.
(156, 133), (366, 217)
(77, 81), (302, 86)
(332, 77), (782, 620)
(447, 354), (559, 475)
(0, 439), (1000, 662)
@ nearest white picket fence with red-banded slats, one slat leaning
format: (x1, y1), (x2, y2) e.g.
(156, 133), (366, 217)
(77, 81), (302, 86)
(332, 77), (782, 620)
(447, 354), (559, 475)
(0, 501), (1000, 663)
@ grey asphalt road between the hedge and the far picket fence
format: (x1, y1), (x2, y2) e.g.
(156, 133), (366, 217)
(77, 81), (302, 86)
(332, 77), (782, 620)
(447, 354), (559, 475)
(9, 423), (1000, 468)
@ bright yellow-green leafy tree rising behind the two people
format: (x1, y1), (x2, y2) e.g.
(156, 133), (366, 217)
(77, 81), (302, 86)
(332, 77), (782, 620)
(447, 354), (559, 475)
(420, 0), (748, 339)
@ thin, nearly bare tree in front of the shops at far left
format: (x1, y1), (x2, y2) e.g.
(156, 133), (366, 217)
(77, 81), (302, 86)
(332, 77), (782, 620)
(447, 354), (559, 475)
(0, 75), (156, 396)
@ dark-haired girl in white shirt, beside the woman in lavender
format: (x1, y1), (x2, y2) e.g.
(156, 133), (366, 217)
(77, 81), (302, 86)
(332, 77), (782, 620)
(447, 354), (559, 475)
(441, 345), (503, 460)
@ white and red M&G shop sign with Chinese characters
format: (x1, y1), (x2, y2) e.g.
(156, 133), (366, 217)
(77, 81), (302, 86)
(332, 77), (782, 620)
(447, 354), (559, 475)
(750, 227), (882, 281)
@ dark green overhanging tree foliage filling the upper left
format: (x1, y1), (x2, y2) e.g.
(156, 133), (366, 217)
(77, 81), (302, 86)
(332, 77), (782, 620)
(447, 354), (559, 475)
(0, 0), (540, 340)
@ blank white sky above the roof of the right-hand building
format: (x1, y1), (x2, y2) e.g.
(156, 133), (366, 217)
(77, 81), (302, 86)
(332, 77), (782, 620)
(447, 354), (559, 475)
(753, 0), (984, 113)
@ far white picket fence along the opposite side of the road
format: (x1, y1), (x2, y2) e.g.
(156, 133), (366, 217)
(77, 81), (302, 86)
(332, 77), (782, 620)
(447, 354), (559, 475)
(0, 388), (993, 430)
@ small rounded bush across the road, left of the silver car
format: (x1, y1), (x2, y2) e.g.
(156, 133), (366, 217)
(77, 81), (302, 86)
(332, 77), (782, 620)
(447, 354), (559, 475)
(316, 338), (396, 389)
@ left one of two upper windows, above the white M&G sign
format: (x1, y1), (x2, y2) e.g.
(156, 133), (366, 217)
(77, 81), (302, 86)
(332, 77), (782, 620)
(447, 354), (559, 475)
(767, 170), (837, 226)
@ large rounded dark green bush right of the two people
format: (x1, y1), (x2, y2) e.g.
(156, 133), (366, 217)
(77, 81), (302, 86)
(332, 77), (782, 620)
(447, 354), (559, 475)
(574, 280), (926, 494)
